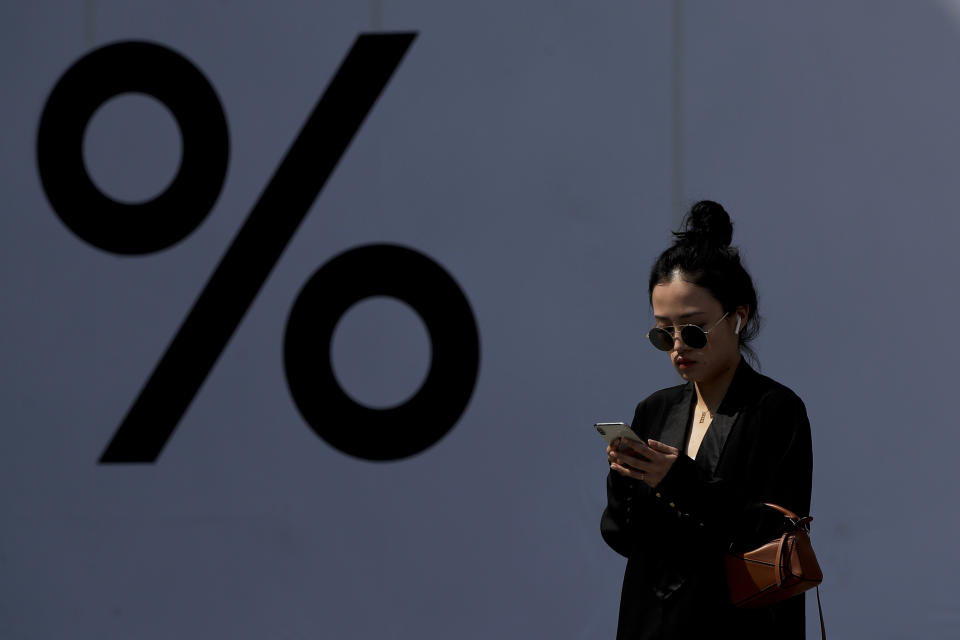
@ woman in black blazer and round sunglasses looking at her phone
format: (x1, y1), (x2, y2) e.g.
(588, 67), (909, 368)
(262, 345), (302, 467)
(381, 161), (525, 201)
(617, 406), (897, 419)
(600, 201), (813, 640)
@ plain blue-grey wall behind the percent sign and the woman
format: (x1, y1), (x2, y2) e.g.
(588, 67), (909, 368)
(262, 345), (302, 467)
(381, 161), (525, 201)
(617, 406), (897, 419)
(0, 0), (960, 639)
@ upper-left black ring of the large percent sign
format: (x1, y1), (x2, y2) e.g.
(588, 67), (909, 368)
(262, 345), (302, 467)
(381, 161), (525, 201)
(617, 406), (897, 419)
(37, 41), (230, 254)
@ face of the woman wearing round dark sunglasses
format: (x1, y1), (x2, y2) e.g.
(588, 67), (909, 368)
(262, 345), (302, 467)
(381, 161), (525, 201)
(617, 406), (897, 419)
(650, 274), (747, 382)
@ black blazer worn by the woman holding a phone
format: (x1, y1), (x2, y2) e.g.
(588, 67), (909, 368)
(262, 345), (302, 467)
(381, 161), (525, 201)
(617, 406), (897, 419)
(600, 361), (813, 640)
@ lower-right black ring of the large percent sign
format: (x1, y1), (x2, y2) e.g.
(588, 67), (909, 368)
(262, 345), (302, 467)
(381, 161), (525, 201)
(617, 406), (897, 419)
(284, 244), (480, 460)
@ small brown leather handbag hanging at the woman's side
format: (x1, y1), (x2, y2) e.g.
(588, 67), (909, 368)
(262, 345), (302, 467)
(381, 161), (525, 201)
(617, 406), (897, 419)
(725, 503), (823, 608)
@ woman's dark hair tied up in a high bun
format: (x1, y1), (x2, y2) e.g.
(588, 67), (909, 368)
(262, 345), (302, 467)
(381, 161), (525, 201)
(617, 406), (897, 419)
(648, 200), (760, 362)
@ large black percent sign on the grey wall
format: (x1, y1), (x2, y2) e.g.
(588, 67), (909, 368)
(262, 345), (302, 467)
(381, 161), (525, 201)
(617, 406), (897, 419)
(37, 33), (480, 463)
